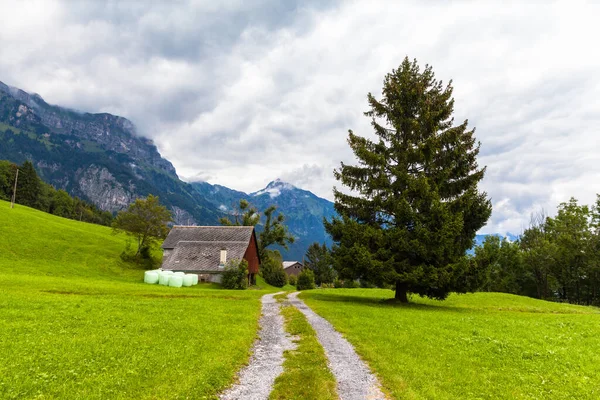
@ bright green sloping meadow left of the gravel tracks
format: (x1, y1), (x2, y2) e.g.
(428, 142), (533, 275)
(0, 201), (268, 399)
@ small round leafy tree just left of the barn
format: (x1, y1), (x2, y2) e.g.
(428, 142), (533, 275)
(112, 195), (173, 256)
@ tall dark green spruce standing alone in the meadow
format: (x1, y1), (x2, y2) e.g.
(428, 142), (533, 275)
(325, 58), (491, 302)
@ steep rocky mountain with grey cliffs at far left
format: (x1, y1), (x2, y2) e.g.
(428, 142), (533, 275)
(0, 82), (220, 224)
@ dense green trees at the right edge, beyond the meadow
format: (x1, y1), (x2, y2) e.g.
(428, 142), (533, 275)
(472, 196), (600, 305)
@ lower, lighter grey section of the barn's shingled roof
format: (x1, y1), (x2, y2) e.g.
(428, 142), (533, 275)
(162, 241), (248, 272)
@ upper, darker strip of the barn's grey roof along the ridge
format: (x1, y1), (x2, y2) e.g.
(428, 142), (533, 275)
(162, 226), (254, 249)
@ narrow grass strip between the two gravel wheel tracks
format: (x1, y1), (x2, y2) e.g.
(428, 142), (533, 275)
(270, 304), (338, 400)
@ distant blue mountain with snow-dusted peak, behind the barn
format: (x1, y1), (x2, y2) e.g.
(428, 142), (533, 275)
(191, 180), (335, 261)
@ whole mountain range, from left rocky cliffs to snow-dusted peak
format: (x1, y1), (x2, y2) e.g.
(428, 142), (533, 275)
(0, 82), (334, 260)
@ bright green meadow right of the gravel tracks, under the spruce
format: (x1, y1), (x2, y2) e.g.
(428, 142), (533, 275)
(300, 289), (600, 399)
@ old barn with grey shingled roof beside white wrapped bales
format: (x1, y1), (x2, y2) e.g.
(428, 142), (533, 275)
(161, 226), (260, 282)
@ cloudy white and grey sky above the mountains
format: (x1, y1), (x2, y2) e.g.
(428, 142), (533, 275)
(0, 0), (600, 233)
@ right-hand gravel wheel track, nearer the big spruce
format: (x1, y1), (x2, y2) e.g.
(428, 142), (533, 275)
(288, 292), (385, 400)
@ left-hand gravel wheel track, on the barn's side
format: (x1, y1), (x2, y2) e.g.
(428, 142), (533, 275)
(220, 292), (296, 400)
